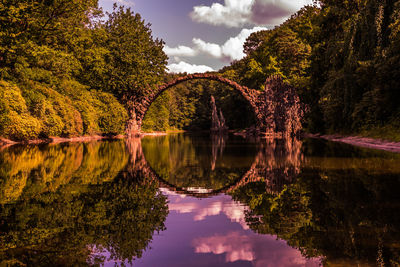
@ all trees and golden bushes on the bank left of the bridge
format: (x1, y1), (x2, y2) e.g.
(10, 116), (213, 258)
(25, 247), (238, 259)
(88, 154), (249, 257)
(0, 0), (167, 140)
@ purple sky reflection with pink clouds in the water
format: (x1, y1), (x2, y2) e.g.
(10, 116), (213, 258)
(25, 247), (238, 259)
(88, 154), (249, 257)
(102, 189), (319, 267)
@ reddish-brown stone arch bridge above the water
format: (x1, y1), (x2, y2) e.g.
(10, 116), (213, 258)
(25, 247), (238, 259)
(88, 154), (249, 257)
(126, 73), (304, 137)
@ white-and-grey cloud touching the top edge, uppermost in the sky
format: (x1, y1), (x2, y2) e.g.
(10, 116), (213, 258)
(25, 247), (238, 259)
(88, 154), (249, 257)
(190, 0), (312, 27)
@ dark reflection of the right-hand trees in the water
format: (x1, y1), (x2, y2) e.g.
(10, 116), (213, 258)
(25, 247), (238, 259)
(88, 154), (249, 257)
(232, 141), (400, 266)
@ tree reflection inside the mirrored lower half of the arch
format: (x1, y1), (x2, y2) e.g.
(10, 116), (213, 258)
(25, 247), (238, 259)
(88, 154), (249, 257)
(141, 135), (256, 190)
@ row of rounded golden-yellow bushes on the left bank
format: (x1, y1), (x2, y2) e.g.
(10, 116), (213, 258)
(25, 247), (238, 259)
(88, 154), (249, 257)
(0, 80), (127, 141)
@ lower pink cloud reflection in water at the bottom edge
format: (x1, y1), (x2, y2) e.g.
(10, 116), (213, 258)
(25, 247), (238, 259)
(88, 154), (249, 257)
(192, 232), (320, 267)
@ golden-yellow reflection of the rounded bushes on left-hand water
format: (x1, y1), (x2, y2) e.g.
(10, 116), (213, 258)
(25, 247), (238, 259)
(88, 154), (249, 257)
(0, 142), (128, 204)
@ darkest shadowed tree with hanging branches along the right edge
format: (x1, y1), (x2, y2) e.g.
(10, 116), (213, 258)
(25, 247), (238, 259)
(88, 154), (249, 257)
(311, 0), (400, 138)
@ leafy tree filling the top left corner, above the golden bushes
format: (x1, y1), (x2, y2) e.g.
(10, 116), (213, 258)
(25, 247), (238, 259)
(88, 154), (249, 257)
(0, 0), (100, 80)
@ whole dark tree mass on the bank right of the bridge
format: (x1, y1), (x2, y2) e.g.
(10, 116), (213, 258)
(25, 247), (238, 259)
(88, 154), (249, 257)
(222, 0), (400, 139)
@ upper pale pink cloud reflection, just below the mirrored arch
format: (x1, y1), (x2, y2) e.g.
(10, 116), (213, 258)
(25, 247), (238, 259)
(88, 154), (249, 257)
(168, 195), (249, 229)
